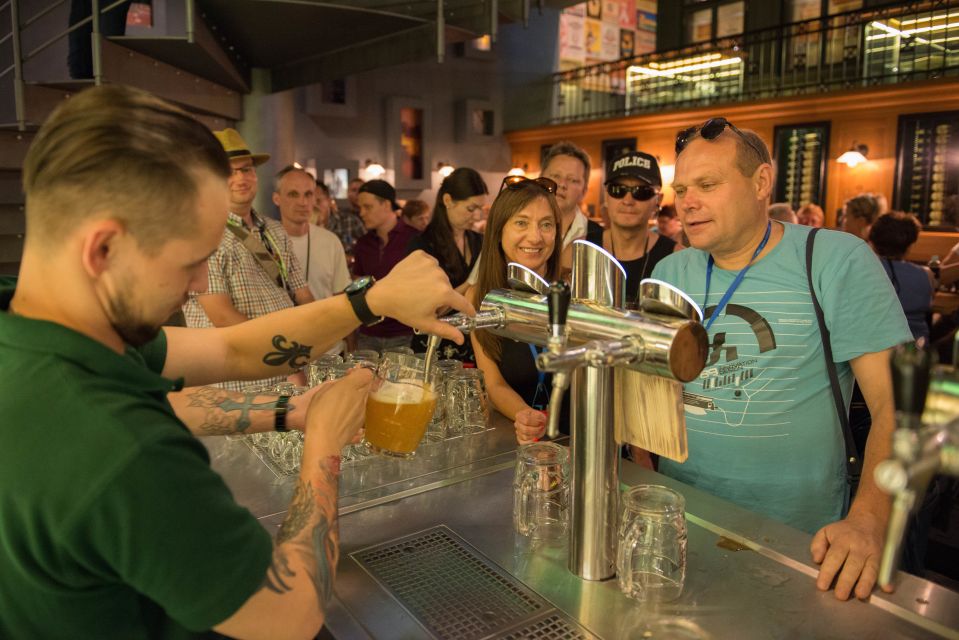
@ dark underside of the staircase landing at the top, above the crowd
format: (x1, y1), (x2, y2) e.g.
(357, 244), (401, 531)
(197, 0), (577, 91)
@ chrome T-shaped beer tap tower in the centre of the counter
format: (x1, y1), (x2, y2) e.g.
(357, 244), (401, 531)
(436, 241), (707, 580)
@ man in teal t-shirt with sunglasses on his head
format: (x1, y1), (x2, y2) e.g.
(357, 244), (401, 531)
(653, 118), (912, 600)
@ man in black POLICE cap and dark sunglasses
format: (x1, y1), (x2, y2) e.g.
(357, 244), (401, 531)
(586, 151), (682, 306)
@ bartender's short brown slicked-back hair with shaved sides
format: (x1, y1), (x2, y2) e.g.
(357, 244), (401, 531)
(23, 85), (230, 252)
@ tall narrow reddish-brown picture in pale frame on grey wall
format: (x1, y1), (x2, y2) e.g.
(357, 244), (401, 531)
(386, 98), (431, 190)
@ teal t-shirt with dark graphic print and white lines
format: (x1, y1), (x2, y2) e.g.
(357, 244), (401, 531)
(653, 223), (912, 533)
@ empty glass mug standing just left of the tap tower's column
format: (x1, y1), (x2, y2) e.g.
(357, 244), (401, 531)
(513, 442), (569, 540)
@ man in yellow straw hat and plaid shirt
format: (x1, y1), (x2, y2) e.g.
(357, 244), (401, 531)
(183, 129), (313, 391)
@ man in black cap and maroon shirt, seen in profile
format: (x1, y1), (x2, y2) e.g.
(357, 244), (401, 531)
(353, 180), (418, 351)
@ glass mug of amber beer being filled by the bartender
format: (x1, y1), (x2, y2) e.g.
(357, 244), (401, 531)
(364, 353), (436, 458)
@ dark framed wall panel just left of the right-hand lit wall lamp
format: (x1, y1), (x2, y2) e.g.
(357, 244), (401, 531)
(773, 122), (829, 210)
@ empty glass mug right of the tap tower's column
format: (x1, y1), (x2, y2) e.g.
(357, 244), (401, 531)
(616, 484), (686, 602)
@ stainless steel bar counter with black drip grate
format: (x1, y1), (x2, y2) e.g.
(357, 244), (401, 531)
(213, 418), (959, 639)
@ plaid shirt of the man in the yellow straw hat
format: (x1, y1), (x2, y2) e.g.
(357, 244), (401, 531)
(183, 213), (306, 391)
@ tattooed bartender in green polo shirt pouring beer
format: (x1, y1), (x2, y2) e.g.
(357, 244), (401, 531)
(0, 86), (472, 639)
